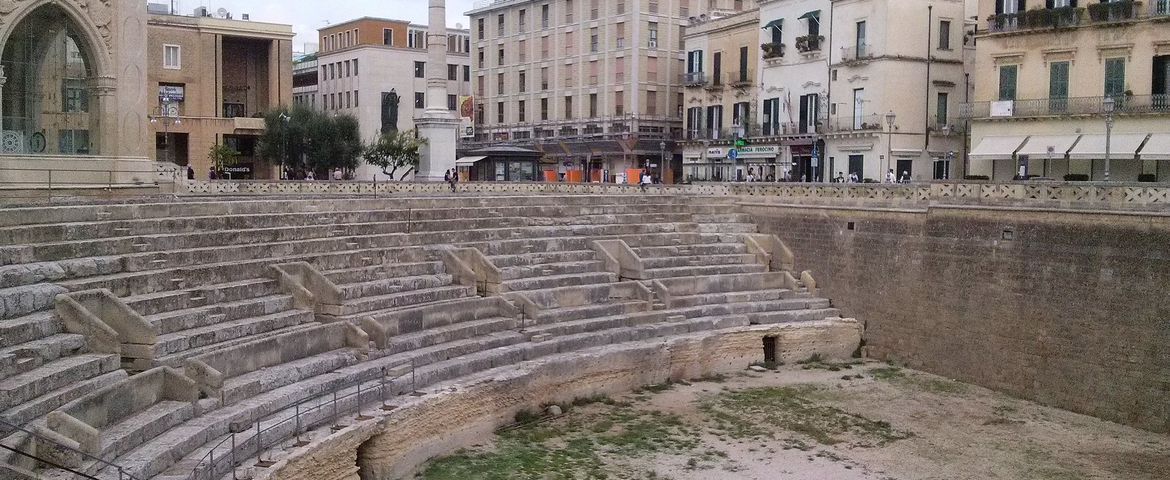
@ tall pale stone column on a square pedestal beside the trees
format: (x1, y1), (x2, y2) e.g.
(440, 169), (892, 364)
(414, 0), (459, 181)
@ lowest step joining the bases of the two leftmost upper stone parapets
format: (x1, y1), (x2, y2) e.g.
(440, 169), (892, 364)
(152, 310), (315, 358)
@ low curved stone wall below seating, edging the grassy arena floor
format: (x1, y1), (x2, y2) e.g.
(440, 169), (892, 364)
(254, 318), (861, 480)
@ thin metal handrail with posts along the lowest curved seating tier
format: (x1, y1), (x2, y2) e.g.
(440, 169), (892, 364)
(187, 358), (415, 480)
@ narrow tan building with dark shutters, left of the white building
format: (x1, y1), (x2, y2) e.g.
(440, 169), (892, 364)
(682, 9), (779, 181)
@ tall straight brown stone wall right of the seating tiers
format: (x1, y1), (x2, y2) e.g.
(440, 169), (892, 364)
(744, 203), (1170, 432)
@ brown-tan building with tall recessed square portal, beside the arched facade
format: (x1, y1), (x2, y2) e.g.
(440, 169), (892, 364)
(146, 6), (294, 179)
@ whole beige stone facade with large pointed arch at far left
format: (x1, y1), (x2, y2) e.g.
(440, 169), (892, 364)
(0, 0), (152, 184)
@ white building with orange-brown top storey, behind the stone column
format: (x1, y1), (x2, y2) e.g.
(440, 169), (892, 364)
(318, 18), (472, 180)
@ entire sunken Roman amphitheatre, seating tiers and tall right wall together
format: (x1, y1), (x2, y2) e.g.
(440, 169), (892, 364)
(0, 183), (1170, 480)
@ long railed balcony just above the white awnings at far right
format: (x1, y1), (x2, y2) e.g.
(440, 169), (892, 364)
(959, 93), (1170, 118)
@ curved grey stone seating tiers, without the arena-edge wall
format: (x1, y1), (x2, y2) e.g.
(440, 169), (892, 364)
(0, 196), (837, 479)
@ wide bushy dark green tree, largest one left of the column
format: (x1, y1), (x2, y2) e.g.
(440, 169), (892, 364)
(256, 105), (364, 172)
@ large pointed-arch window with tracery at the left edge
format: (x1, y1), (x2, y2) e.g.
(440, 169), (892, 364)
(0, 5), (101, 156)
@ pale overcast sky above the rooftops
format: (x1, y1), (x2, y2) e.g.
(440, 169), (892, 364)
(170, 0), (479, 52)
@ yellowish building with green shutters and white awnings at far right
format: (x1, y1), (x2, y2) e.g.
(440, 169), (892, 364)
(963, 0), (1170, 181)
